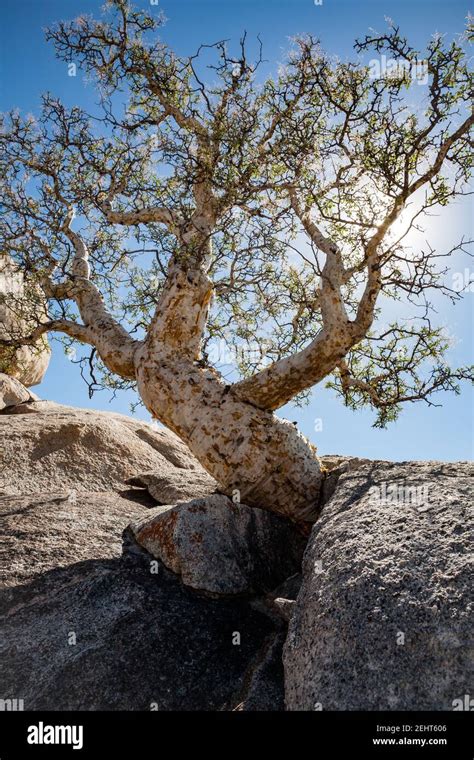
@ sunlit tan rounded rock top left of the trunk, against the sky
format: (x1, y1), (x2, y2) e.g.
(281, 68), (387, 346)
(0, 401), (208, 496)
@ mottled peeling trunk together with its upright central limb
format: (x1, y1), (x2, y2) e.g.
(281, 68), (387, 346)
(135, 226), (322, 522)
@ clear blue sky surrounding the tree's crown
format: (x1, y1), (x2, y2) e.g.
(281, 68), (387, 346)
(0, 0), (474, 460)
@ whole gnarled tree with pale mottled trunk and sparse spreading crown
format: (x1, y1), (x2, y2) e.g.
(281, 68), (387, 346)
(0, 0), (474, 522)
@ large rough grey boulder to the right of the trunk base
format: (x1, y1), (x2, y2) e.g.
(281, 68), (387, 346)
(284, 462), (474, 710)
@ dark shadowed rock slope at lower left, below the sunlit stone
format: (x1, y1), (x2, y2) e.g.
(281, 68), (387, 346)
(0, 510), (283, 711)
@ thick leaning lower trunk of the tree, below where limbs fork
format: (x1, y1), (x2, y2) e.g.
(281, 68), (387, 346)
(135, 341), (322, 523)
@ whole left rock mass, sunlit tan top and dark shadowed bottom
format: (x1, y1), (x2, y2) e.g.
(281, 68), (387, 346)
(0, 402), (283, 711)
